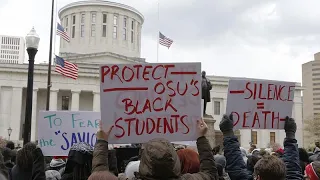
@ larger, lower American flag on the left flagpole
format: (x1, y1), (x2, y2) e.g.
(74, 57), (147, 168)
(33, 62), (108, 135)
(55, 56), (79, 79)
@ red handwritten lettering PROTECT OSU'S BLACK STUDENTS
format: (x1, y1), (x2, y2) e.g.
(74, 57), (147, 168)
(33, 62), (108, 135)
(100, 64), (201, 141)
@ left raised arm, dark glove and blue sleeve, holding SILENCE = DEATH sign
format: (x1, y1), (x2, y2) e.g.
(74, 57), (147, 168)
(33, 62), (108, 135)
(219, 115), (249, 180)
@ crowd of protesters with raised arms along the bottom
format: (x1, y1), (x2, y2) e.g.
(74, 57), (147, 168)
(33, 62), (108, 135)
(0, 115), (320, 180)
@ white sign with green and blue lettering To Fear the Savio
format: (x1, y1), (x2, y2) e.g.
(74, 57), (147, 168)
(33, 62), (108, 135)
(38, 111), (100, 156)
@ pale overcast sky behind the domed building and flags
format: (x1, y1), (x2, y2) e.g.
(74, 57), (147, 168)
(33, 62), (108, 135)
(0, 0), (320, 82)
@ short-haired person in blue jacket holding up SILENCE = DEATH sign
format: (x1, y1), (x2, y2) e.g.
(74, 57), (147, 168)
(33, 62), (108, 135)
(219, 114), (303, 180)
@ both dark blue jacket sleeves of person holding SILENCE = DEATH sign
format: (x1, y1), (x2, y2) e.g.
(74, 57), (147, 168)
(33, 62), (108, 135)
(223, 136), (303, 180)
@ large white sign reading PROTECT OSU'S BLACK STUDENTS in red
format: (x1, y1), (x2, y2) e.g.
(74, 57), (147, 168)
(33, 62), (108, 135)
(100, 63), (202, 144)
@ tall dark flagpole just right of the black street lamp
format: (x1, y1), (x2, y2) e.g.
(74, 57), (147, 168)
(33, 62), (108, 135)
(46, 0), (54, 111)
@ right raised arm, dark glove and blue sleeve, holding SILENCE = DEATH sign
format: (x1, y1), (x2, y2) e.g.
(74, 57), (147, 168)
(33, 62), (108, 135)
(282, 117), (303, 180)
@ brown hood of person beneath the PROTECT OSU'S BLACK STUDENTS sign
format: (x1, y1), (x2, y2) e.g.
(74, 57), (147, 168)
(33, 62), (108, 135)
(139, 139), (181, 180)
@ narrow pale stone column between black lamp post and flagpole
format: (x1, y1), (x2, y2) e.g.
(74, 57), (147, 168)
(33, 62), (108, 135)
(31, 89), (38, 142)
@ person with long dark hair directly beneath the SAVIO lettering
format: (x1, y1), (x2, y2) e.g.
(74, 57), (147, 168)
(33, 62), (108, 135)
(61, 142), (93, 180)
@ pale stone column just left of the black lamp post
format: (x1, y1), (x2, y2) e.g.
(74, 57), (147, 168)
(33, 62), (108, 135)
(10, 87), (22, 141)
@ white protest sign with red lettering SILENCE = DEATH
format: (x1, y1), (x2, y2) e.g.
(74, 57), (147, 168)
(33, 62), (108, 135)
(227, 79), (295, 129)
